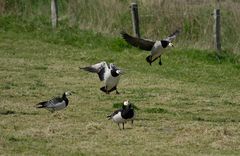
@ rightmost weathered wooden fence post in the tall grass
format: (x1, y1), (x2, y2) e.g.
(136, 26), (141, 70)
(213, 0), (221, 54)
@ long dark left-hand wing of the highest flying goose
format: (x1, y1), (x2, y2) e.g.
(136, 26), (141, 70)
(121, 31), (155, 51)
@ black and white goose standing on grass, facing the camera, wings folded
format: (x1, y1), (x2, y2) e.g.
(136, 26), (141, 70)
(107, 100), (134, 130)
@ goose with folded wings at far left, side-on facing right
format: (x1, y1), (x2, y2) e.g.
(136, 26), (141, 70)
(37, 92), (71, 112)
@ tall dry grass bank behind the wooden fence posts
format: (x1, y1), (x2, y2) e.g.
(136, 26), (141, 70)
(0, 0), (240, 54)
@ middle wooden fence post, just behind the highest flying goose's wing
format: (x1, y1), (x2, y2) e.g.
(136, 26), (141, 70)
(131, 3), (140, 38)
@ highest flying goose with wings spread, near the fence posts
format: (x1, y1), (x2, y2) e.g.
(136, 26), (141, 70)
(121, 30), (180, 65)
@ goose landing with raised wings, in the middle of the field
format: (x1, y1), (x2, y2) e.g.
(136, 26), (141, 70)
(80, 61), (123, 94)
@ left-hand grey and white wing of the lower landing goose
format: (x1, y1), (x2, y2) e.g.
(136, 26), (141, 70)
(80, 61), (108, 81)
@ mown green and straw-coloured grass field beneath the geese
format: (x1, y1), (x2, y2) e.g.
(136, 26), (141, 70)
(0, 26), (240, 156)
